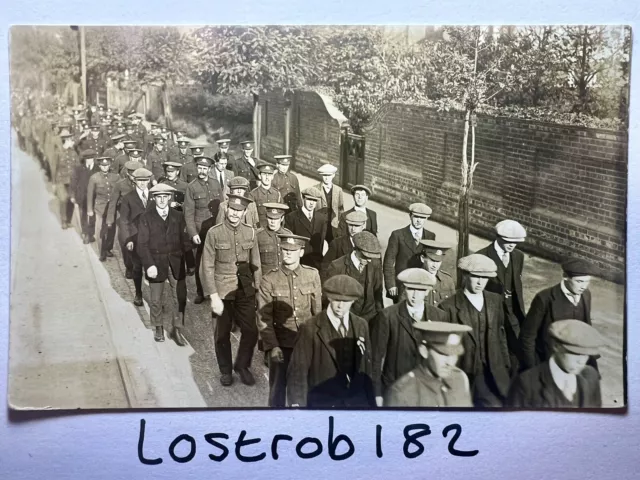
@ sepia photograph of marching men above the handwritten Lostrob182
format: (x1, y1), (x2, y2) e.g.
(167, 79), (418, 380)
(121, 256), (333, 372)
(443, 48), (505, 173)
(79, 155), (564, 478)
(8, 25), (631, 415)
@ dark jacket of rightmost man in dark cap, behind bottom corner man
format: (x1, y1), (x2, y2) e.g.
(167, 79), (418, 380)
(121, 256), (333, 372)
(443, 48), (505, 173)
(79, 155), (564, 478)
(520, 283), (591, 368)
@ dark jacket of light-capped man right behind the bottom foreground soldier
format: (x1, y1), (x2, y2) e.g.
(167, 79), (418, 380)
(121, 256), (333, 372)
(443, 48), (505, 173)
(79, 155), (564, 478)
(369, 301), (447, 396)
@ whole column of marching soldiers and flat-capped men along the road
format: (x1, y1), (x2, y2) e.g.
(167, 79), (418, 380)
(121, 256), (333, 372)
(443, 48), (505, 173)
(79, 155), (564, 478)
(13, 97), (603, 408)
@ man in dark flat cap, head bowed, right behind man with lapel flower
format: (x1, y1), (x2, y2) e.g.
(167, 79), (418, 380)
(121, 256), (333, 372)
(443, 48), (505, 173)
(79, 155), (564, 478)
(324, 232), (384, 322)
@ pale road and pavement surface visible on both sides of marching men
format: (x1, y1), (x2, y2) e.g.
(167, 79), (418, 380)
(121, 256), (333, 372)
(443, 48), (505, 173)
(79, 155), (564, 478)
(9, 133), (624, 409)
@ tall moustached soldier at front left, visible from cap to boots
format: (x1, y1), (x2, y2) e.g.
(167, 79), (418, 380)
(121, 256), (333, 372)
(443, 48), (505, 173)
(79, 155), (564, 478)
(200, 195), (262, 386)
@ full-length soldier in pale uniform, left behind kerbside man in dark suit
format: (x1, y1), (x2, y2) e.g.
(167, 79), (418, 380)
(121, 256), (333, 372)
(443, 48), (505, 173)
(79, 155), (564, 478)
(87, 157), (120, 262)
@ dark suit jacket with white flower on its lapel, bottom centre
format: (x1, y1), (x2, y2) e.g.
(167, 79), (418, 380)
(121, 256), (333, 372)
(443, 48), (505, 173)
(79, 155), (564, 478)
(287, 311), (375, 408)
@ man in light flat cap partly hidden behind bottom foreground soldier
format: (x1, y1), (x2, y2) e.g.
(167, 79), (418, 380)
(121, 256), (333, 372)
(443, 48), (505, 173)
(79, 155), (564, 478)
(369, 268), (447, 406)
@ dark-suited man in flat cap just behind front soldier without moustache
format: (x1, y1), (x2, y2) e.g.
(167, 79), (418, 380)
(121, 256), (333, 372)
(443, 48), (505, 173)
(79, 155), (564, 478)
(284, 187), (329, 270)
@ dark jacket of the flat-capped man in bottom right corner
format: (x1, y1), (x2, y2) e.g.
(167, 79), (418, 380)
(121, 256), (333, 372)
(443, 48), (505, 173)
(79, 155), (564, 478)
(506, 361), (602, 408)
